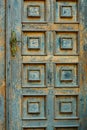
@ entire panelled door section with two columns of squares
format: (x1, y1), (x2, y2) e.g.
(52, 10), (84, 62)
(21, 0), (80, 130)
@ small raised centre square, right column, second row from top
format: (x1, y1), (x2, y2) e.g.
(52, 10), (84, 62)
(60, 37), (73, 50)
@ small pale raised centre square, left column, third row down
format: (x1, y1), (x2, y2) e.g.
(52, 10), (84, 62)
(28, 70), (40, 82)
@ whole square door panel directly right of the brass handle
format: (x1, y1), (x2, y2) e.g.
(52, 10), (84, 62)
(22, 32), (47, 55)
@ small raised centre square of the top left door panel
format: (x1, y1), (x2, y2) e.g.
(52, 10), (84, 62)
(27, 5), (40, 17)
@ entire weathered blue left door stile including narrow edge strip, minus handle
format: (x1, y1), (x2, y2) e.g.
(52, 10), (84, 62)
(6, 0), (22, 130)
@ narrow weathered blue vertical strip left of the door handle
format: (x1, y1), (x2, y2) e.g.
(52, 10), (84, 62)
(6, 0), (11, 130)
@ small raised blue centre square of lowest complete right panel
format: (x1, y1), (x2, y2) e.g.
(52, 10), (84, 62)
(60, 102), (72, 113)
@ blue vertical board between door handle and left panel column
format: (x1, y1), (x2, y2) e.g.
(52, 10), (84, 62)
(9, 0), (22, 130)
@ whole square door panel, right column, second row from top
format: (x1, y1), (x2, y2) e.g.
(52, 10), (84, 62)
(54, 32), (79, 55)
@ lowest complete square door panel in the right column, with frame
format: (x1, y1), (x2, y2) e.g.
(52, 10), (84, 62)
(55, 95), (78, 119)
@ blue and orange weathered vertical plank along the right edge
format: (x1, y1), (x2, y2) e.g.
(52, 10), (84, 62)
(79, 0), (87, 130)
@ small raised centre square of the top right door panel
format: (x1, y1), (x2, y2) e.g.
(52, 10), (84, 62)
(60, 6), (72, 17)
